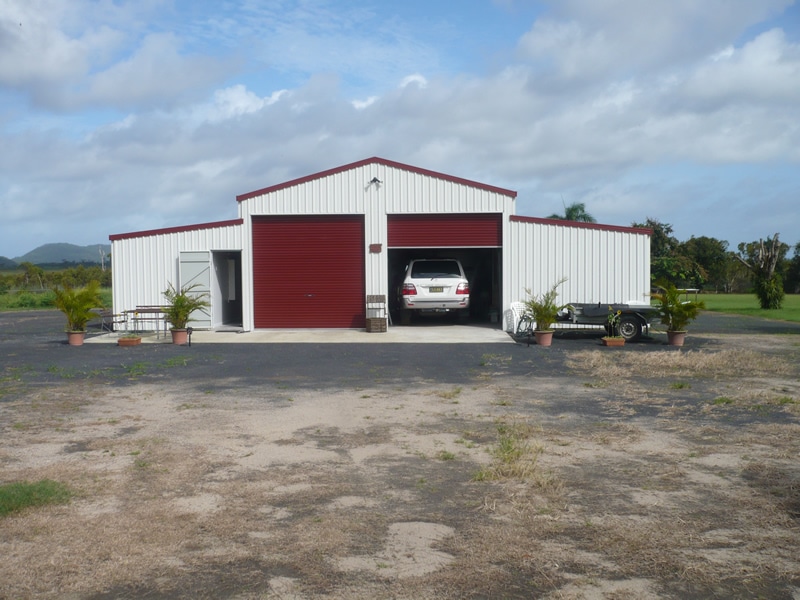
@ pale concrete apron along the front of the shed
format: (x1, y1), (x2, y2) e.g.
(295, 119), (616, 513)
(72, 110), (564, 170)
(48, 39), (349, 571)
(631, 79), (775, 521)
(85, 323), (514, 344)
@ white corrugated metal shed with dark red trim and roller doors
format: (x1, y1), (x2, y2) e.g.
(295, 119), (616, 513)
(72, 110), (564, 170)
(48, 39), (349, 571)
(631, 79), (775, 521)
(110, 158), (651, 331)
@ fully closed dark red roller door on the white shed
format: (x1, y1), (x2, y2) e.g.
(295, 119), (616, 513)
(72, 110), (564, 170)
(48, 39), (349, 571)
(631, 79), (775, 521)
(253, 215), (366, 328)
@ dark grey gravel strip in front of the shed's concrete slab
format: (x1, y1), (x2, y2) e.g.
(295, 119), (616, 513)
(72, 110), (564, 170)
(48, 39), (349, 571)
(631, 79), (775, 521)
(0, 311), (800, 388)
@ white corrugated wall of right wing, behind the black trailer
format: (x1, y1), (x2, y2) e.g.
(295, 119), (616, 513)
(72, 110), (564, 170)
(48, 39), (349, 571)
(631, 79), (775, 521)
(505, 219), (650, 303)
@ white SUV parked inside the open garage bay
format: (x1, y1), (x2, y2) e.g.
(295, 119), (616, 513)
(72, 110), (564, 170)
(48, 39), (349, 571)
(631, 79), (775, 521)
(400, 258), (469, 319)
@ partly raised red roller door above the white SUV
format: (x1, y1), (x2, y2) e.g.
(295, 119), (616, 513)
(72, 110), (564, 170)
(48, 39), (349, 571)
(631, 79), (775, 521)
(388, 213), (503, 248)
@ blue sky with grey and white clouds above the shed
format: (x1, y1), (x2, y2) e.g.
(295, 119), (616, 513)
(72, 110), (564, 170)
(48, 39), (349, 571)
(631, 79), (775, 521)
(0, 0), (800, 257)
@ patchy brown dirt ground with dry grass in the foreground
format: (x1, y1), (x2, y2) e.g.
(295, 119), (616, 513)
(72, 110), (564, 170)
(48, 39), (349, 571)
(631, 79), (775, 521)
(0, 324), (800, 600)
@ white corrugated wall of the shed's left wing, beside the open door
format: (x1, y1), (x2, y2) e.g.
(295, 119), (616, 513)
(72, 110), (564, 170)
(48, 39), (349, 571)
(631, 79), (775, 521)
(111, 225), (243, 324)
